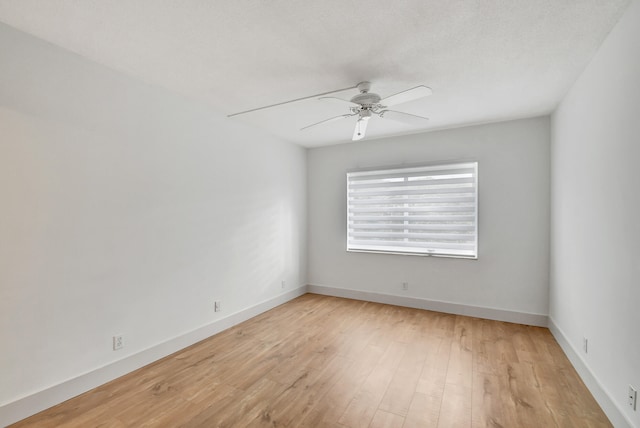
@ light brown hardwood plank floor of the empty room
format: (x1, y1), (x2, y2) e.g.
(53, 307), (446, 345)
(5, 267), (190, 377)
(8, 294), (611, 428)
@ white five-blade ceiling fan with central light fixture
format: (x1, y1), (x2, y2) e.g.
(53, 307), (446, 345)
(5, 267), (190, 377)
(228, 82), (432, 141)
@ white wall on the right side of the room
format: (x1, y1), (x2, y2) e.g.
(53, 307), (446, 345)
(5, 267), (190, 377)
(550, 0), (640, 426)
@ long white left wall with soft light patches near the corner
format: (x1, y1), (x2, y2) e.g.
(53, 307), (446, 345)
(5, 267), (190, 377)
(0, 21), (306, 416)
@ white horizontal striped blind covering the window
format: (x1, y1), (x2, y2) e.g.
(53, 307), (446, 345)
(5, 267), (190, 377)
(347, 162), (478, 258)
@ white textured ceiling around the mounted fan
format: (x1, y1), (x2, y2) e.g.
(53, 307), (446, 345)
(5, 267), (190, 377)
(0, 0), (630, 147)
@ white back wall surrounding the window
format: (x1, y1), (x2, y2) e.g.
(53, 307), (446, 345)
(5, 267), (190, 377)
(308, 118), (549, 320)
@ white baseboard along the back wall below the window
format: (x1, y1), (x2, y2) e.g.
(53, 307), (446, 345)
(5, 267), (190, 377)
(307, 284), (547, 327)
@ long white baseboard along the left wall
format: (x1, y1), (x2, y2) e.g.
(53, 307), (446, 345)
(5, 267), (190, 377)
(0, 286), (307, 427)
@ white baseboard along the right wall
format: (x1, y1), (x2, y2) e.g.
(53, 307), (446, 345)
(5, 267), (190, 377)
(549, 317), (634, 428)
